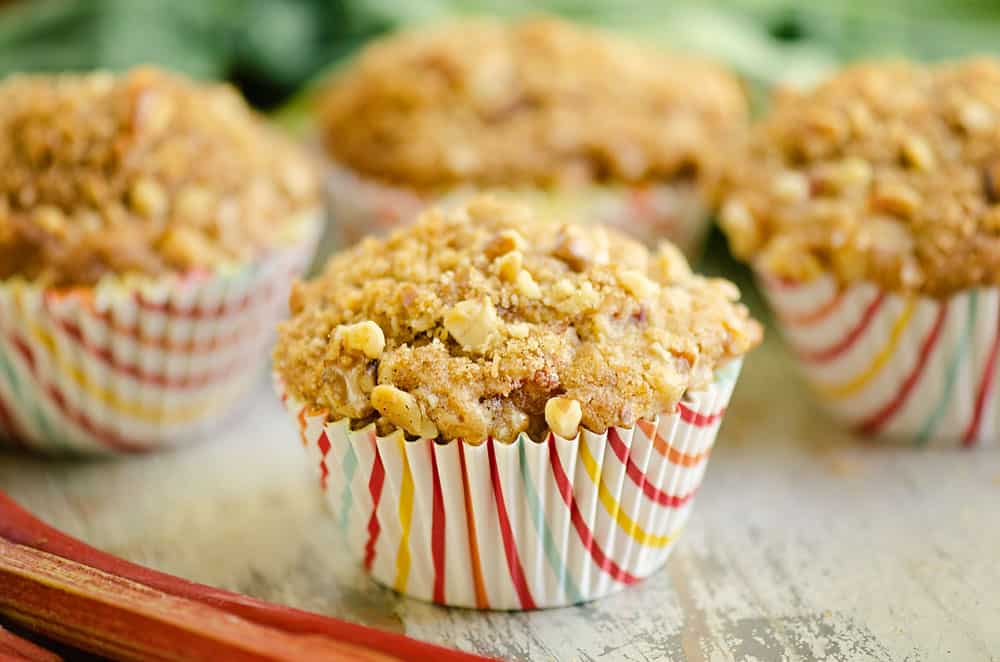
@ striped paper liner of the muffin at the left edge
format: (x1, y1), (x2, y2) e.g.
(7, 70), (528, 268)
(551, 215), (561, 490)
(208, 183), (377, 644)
(0, 215), (320, 454)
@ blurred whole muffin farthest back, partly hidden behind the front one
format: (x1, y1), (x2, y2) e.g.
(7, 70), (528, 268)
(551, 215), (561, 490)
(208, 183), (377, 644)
(318, 19), (747, 260)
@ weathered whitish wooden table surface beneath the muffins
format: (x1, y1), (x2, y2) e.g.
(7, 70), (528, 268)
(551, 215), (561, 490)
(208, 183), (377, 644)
(0, 334), (1000, 661)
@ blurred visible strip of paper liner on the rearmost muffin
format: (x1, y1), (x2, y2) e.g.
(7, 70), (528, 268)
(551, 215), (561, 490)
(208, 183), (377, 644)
(320, 165), (710, 257)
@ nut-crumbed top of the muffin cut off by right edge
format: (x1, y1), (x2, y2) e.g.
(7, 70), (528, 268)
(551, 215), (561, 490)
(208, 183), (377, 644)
(721, 59), (1000, 296)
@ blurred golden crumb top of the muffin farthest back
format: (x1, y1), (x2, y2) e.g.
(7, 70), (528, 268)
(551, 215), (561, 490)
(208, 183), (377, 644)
(319, 19), (747, 190)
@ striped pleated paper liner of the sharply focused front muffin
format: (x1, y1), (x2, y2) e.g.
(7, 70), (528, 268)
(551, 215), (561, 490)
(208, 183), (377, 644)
(278, 361), (740, 610)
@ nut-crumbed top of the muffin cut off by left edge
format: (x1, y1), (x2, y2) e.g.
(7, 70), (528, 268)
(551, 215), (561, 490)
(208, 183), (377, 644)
(0, 69), (320, 287)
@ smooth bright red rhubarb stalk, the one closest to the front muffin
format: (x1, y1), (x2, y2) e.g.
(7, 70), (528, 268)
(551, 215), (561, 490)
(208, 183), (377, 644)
(0, 492), (486, 662)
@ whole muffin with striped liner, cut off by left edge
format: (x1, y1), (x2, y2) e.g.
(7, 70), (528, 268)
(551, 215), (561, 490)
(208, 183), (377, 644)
(0, 69), (322, 453)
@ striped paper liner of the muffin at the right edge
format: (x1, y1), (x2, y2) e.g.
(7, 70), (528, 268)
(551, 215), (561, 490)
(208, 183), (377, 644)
(759, 275), (1000, 447)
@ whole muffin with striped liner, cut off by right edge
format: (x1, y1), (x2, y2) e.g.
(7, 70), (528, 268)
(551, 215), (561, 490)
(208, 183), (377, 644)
(721, 59), (1000, 446)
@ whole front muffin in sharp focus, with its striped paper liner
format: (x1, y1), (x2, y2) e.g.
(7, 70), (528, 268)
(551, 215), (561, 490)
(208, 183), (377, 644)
(274, 197), (761, 609)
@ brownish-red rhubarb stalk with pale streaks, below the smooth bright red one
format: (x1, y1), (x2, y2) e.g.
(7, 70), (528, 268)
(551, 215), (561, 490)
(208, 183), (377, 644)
(0, 540), (399, 662)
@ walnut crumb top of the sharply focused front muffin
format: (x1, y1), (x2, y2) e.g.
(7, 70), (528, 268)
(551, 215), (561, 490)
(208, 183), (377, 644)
(274, 197), (761, 442)
